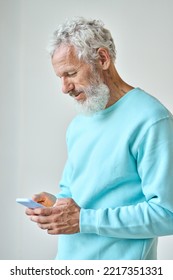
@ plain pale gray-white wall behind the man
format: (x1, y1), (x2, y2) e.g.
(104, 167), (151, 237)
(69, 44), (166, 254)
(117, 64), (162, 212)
(0, 0), (173, 259)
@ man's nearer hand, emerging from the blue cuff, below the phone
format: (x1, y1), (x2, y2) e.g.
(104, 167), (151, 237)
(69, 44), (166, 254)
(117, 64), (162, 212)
(26, 198), (80, 234)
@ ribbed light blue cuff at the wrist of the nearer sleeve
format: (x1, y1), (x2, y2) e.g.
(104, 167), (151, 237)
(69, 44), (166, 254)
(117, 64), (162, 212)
(80, 208), (99, 234)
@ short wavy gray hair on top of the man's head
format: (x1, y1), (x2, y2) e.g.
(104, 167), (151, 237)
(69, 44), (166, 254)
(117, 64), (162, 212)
(48, 17), (116, 63)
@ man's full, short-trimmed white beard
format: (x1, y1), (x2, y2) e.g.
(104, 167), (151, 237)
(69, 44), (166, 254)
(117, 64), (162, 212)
(75, 83), (110, 115)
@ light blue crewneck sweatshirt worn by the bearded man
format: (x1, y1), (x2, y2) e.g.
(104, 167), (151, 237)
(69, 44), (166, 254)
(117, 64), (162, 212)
(57, 88), (173, 260)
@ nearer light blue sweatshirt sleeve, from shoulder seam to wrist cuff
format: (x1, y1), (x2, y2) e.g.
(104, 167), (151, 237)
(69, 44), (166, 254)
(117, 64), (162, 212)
(80, 117), (173, 239)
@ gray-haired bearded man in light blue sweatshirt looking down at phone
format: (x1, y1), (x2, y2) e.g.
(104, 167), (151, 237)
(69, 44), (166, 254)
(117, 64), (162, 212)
(26, 18), (173, 260)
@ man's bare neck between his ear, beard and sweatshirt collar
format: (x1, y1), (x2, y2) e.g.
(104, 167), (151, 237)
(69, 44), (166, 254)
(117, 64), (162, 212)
(104, 64), (133, 108)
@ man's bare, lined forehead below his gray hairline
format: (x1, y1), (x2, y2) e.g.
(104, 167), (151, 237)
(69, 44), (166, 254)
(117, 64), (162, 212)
(52, 45), (84, 75)
